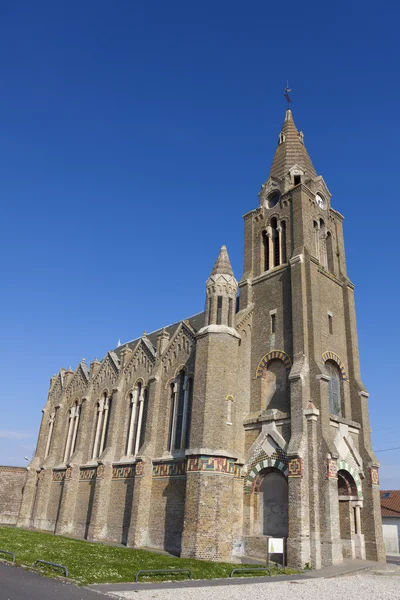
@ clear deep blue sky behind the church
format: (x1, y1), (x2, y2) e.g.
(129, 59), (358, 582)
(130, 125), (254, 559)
(0, 0), (400, 488)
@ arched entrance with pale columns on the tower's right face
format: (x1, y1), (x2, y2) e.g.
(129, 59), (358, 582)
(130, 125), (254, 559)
(338, 469), (365, 559)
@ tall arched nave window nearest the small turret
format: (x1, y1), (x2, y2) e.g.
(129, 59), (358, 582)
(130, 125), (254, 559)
(168, 369), (193, 454)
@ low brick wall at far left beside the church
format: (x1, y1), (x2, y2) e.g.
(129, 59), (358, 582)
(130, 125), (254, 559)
(0, 466), (26, 525)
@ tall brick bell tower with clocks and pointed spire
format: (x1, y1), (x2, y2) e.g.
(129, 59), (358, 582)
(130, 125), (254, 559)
(239, 110), (385, 568)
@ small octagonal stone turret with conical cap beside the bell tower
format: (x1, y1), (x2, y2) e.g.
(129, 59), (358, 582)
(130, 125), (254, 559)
(205, 246), (238, 330)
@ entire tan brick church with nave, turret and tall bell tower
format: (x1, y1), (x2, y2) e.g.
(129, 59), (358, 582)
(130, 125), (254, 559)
(9, 110), (384, 568)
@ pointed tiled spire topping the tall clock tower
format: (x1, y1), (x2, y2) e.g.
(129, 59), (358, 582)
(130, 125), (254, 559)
(269, 109), (317, 179)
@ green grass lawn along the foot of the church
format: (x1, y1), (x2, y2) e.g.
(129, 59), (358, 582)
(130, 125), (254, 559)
(0, 527), (298, 584)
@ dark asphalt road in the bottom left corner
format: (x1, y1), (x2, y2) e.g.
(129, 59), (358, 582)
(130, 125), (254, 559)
(0, 563), (110, 600)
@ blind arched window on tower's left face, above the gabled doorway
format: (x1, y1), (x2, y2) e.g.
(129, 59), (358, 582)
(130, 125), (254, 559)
(261, 359), (290, 412)
